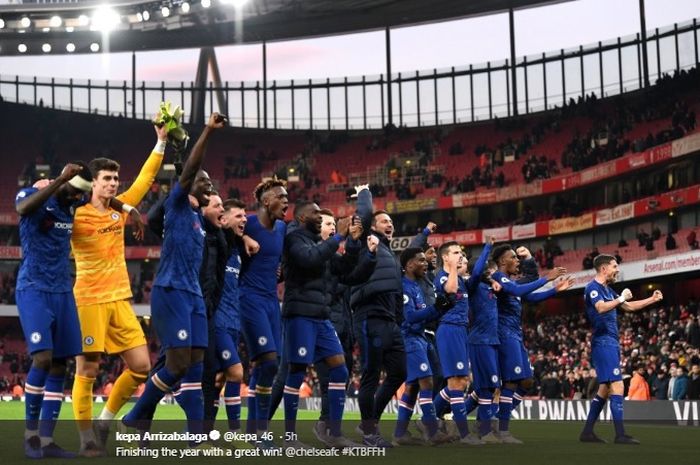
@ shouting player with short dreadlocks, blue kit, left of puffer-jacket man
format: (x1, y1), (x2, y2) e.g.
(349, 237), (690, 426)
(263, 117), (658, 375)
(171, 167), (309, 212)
(240, 178), (289, 447)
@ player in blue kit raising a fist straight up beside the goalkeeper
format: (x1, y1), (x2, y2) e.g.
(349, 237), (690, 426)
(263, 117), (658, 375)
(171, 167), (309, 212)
(122, 113), (226, 434)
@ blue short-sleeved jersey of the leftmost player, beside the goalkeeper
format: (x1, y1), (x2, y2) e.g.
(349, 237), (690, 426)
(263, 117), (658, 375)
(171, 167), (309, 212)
(15, 187), (85, 292)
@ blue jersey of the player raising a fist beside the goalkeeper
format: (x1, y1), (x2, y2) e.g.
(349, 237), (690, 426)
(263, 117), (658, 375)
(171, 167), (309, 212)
(153, 182), (207, 296)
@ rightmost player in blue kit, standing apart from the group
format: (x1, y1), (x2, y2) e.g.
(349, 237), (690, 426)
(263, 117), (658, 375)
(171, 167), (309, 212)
(579, 254), (664, 444)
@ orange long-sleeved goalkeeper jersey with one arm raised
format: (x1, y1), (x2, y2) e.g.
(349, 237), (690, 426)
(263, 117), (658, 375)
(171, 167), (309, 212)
(71, 151), (163, 306)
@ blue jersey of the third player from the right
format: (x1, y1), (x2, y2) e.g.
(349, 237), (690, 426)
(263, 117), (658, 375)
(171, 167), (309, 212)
(469, 281), (499, 344)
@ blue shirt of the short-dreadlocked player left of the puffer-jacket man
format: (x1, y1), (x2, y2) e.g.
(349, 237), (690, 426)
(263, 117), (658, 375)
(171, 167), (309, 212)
(240, 215), (287, 299)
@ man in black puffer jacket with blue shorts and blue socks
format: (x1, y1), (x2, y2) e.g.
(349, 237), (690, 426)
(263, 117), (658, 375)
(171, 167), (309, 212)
(282, 201), (377, 448)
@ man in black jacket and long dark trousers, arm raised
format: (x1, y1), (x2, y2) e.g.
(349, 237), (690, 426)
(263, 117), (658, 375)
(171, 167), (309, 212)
(350, 186), (406, 448)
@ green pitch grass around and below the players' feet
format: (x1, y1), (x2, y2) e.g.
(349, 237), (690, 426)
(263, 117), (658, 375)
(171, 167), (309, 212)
(0, 402), (700, 465)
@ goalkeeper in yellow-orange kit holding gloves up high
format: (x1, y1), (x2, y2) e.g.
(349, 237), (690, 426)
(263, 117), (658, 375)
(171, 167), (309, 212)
(71, 121), (167, 457)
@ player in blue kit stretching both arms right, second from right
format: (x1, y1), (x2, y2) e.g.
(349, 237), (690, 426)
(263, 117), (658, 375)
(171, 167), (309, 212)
(491, 244), (573, 444)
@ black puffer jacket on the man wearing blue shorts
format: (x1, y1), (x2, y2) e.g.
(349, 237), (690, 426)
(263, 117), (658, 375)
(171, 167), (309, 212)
(282, 227), (377, 319)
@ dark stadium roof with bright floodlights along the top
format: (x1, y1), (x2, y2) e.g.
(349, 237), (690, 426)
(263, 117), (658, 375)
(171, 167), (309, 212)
(0, 0), (570, 55)
